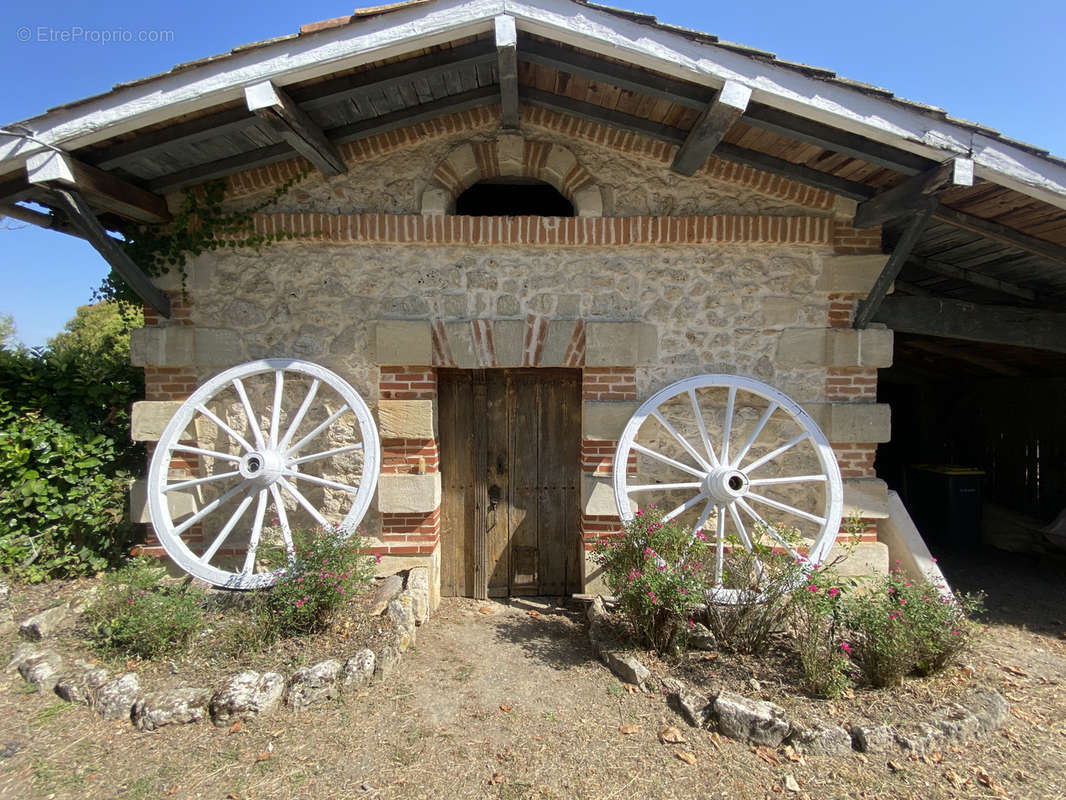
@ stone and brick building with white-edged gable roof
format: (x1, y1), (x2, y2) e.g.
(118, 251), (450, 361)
(0, 0), (1066, 597)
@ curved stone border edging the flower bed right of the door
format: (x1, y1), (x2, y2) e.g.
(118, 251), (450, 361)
(587, 596), (1011, 755)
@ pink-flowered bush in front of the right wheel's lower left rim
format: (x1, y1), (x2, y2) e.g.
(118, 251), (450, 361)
(593, 506), (708, 653)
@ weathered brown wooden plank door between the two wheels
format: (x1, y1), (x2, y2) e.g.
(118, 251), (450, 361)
(437, 369), (581, 597)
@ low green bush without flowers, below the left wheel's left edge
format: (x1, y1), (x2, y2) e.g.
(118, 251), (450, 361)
(85, 557), (205, 659)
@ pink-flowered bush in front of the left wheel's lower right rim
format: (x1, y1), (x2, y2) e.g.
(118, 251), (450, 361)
(256, 529), (374, 641)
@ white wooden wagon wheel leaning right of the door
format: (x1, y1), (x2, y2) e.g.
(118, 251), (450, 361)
(614, 374), (843, 603)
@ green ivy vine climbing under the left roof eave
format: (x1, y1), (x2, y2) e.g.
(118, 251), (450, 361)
(96, 167), (312, 303)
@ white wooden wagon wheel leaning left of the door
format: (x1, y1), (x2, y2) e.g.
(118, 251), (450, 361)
(148, 358), (381, 589)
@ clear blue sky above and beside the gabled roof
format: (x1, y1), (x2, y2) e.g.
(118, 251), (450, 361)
(0, 0), (1066, 346)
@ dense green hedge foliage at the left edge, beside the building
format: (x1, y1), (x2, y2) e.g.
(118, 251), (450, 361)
(0, 303), (144, 581)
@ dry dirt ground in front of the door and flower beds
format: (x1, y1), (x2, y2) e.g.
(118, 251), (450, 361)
(0, 551), (1066, 800)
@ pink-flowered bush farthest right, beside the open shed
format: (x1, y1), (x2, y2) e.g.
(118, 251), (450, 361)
(845, 571), (984, 687)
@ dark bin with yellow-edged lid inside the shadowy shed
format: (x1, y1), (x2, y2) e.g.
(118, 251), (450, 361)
(906, 464), (985, 547)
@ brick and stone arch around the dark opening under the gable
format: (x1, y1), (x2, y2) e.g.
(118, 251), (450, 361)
(421, 133), (603, 217)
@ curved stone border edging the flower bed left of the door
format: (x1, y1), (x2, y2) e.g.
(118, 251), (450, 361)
(6, 566), (430, 731)
